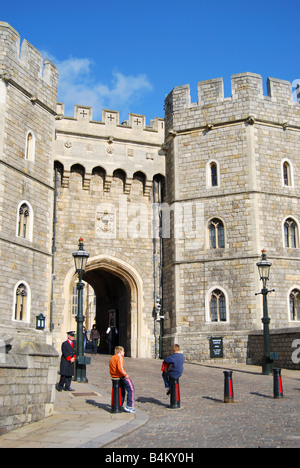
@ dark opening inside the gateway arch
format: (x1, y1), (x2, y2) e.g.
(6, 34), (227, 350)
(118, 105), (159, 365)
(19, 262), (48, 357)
(84, 268), (130, 354)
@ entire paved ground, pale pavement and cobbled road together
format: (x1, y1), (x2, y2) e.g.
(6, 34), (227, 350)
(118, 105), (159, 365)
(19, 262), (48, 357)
(0, 355), (300, 453)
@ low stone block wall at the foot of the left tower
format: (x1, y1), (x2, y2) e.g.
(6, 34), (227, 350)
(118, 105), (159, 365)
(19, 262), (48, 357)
(0, 342), (58, 434)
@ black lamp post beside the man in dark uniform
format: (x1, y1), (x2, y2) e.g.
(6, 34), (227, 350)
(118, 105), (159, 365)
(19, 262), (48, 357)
(72, 239), (90, 383)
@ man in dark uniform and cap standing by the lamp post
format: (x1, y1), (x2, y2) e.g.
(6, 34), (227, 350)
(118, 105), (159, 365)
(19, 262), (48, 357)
(57, 331), (76, 392)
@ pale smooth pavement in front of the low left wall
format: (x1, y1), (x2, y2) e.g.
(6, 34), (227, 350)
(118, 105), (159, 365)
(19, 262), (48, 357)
(0, 374), (141, 448)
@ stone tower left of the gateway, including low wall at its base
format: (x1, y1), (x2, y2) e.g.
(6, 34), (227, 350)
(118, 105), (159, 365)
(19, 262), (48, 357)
(0, 22), (58, 433)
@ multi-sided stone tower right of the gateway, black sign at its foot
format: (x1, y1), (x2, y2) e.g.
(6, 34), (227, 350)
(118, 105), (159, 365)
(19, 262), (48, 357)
(164, 73), (300, 360)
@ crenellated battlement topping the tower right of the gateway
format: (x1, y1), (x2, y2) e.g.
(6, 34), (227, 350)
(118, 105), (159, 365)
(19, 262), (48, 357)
(165, 73), (300, 131)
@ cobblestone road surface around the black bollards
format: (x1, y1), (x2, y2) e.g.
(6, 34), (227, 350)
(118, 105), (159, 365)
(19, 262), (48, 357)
(88, 355), (300, 448)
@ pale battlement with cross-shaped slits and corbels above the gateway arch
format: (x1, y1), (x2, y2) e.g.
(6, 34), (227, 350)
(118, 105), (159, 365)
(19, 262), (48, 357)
(55, 103), (165, 197)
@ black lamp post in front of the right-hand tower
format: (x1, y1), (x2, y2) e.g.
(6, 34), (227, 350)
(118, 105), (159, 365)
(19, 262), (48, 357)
(256, 250), (275, 375)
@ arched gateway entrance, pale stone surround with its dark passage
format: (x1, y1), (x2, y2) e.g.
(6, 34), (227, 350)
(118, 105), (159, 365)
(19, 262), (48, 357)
(66, 256), (148, 357)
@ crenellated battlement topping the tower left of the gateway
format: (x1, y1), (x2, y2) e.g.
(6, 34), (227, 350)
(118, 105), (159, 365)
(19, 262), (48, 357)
(0, 22), (58, 113)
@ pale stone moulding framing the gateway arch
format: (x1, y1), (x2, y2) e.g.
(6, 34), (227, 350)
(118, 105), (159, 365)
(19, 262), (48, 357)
(61, 255), (146, 358)
